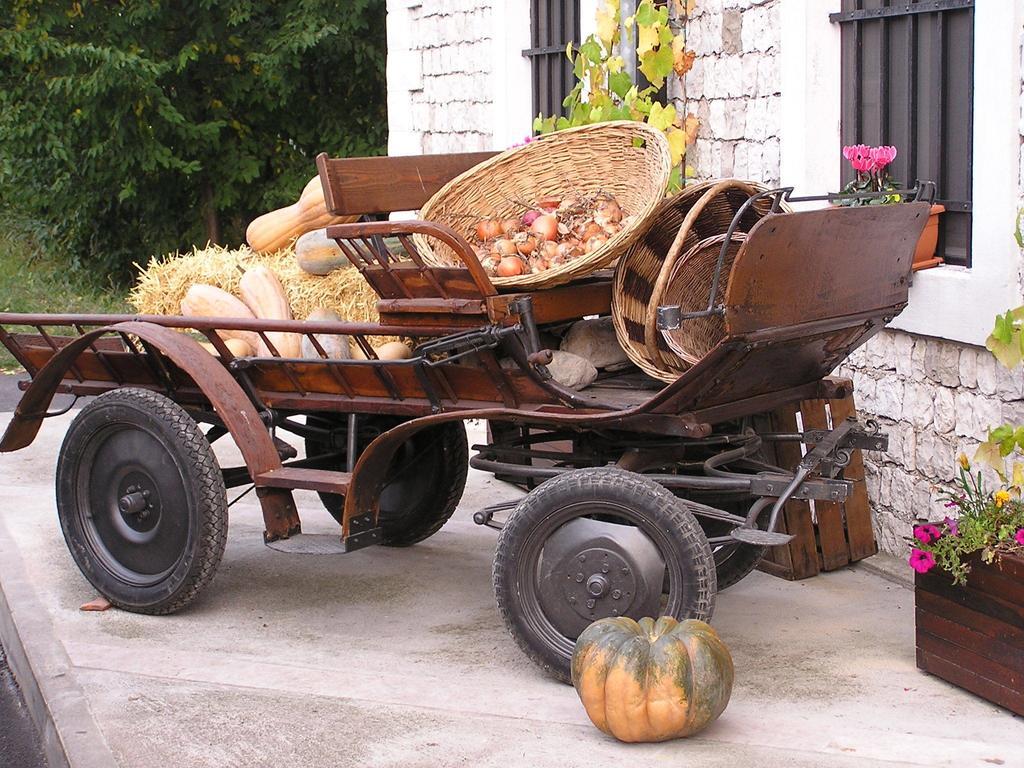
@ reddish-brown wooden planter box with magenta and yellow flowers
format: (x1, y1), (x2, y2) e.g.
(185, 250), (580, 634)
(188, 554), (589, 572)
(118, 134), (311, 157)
(914, 556), (1024, 715)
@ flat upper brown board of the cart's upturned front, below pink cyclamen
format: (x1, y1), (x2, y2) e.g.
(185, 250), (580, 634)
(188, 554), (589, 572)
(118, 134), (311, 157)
(725, 203), (930, 336)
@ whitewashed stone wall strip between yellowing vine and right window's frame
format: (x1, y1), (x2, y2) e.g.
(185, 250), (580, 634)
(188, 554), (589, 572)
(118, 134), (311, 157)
(676, 0), (781, 183)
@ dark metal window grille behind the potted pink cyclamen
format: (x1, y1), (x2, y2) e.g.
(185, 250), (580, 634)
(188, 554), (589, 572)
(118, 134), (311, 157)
(829, 0), (974, 266)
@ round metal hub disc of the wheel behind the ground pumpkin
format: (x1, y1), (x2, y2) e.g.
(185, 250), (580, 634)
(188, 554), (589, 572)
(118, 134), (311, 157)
(538, 518), (665, 637)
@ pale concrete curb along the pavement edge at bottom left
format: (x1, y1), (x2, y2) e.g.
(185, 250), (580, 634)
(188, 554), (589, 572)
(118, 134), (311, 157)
(0, 518), (118, 768)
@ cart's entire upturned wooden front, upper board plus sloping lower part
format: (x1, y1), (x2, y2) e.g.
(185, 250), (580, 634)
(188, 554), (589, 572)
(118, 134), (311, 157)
(653, 203), (929, 423)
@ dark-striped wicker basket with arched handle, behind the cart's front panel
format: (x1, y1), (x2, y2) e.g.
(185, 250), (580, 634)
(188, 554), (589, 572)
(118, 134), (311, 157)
(611, 179), (772, 382)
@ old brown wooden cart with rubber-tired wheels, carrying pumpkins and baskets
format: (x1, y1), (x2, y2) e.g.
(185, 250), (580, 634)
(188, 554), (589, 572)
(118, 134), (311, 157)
(0, 155), (929, 679)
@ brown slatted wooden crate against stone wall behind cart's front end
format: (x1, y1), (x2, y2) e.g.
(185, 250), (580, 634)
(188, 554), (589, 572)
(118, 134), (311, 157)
(758, 380), (879, 580)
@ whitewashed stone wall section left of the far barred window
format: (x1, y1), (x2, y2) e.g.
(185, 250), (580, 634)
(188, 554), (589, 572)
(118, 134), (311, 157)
(387, 0), (497, 155)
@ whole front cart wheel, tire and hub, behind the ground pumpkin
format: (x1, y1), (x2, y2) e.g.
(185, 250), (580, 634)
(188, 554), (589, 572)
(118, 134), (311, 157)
(494, 467), (716, 682)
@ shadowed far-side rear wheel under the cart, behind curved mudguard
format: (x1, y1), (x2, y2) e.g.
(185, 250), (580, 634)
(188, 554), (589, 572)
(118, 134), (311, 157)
(306, 416), (469, 547)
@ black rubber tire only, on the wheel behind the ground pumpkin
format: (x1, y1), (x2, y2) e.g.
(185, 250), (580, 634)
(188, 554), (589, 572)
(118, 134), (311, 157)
(493, 467), (717, 683)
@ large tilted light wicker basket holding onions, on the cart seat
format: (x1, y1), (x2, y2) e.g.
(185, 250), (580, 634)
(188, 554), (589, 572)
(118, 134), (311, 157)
(415, 121), (672, 289)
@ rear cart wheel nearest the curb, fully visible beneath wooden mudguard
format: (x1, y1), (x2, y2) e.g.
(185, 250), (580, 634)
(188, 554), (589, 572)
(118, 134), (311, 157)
(56, 388), (227, 613)
